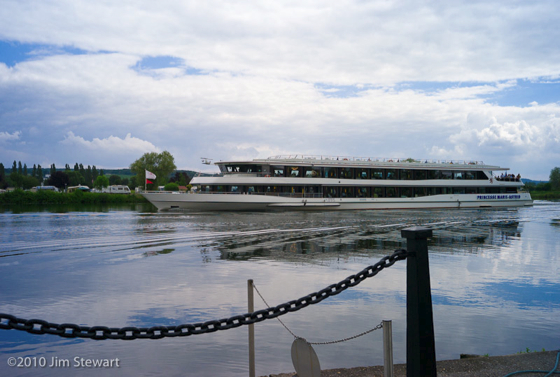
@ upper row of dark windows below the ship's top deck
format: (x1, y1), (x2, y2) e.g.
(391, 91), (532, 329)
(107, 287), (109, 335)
(220, 165), (488, 180)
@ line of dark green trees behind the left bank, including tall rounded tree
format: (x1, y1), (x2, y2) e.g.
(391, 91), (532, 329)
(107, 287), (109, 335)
(0, 151), (191, 190)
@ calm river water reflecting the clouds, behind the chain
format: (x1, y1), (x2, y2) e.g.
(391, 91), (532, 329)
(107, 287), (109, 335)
(0, 201), (560, 376)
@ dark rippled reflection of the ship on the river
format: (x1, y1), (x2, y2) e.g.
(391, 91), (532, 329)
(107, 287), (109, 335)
(216, 220), (521, 262)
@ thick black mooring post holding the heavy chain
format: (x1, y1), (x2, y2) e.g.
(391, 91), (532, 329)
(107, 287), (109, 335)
(401, 226), (437, 377)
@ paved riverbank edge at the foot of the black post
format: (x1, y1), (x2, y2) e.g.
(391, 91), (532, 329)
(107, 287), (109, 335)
(268, 350), (560, 377)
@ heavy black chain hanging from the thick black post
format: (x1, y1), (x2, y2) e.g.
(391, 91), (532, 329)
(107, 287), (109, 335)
(0, 249), (409, 340)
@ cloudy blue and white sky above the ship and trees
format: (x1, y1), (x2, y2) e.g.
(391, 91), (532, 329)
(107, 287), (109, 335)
(0, 0), (560, 180)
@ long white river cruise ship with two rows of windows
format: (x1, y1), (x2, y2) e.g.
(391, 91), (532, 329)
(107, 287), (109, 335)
(142, 155), (533, 211)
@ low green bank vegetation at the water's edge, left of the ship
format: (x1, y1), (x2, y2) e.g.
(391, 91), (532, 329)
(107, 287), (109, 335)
(0, 190), (148, 205)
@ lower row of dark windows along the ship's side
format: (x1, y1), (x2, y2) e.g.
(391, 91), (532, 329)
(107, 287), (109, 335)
(199, 185), (517, 198)
